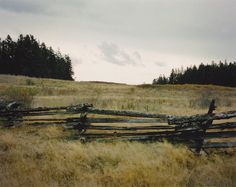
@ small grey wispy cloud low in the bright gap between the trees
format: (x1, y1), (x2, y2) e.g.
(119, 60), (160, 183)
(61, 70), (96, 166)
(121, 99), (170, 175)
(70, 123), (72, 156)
(98, 42), (141, 65)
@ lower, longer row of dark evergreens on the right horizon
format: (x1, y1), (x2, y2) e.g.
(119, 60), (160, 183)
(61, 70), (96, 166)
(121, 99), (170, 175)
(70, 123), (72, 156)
(153, 61), (236, 87)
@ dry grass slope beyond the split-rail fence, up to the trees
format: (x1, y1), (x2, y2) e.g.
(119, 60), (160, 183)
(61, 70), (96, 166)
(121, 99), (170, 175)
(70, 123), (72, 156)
(0, 75), (236, 115)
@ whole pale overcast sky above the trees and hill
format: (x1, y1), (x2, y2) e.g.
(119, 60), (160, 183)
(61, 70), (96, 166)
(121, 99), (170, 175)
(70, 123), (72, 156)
(0, 0), (236, 84)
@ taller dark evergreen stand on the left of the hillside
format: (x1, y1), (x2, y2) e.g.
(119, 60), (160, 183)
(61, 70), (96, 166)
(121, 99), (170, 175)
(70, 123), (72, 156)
(0, 35), (73, 80)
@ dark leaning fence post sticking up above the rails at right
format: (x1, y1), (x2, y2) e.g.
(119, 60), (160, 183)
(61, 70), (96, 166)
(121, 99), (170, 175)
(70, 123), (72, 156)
(195, 99), (216, 153)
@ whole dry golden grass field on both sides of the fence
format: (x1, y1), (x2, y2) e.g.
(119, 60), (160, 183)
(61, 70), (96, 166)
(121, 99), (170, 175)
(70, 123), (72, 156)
(0, 75), (236, 187)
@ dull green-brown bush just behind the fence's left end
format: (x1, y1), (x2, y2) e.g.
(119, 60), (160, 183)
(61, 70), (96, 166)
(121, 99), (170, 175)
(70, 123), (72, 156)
(2, 87), (37, 108)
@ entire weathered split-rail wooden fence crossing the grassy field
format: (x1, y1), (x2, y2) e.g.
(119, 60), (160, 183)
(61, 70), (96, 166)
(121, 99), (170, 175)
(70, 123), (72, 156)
(0, 100), (236, 152)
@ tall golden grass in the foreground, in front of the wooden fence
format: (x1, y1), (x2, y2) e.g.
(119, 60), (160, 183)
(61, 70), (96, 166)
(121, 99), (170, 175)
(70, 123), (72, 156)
(0, 127), (236, 187)
